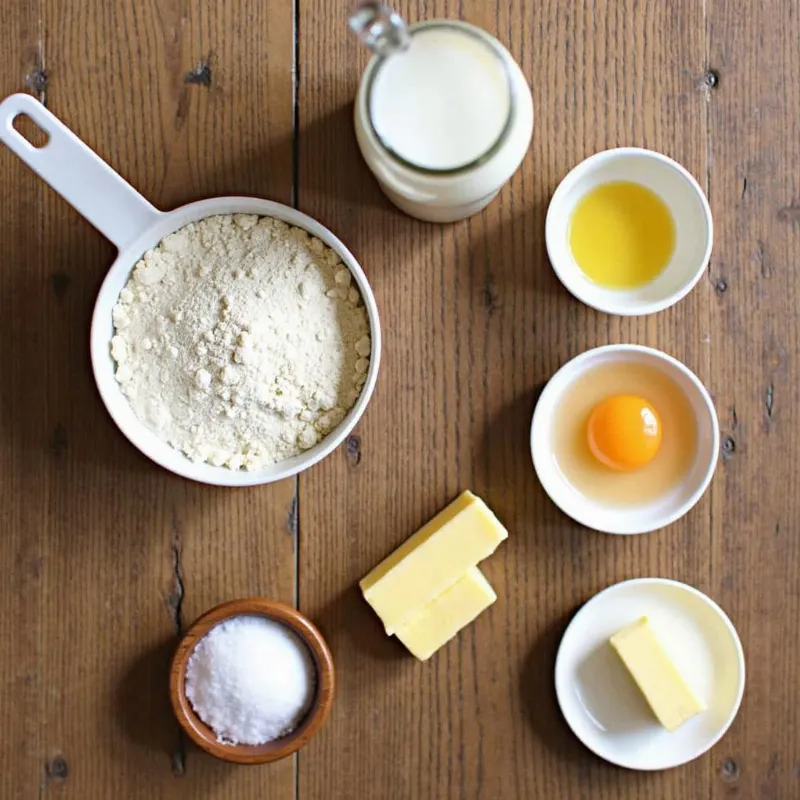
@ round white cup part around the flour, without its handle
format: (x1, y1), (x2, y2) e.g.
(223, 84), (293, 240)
(91, 197), (381, 486)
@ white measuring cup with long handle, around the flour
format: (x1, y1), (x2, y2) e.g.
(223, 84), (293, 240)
(0, 94), (381, 486)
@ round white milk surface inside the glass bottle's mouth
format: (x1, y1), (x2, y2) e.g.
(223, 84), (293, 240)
(369, 26), (511, 170)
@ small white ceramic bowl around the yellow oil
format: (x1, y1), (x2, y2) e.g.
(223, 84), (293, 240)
(545, 147), (714, 316)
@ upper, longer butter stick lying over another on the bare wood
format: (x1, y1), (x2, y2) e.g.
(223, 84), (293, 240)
(360, 491), (508, 635)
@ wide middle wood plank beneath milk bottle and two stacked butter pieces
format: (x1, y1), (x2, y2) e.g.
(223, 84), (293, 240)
(298, 0), (713, 800)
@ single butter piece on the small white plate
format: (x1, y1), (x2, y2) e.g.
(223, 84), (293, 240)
(609, 617), (706, 731)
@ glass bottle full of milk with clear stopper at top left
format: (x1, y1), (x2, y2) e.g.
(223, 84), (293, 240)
(350, 3), (533, 222)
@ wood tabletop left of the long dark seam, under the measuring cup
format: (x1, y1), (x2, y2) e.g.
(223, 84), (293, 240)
(0, 0), (294, 798)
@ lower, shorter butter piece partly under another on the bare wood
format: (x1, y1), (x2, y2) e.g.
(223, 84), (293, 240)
(396, 567), (497, 661)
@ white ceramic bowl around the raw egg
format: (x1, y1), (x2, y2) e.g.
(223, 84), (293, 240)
(531, 344), (719, 534)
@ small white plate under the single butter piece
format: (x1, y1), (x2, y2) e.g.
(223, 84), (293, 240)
(556, 578), (744, 770)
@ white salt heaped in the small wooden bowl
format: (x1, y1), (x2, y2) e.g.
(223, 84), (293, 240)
(186, 616), (316, 745)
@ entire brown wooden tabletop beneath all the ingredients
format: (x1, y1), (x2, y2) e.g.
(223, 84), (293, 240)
(0, 0), (800, 800)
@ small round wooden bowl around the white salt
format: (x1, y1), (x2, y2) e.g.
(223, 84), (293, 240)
(169, 597), (335, 764)
